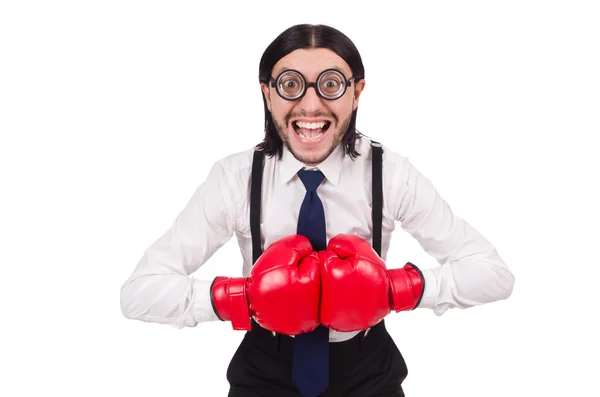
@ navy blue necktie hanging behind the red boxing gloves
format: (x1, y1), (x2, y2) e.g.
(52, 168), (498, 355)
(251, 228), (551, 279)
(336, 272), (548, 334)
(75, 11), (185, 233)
(292, 170), (329, 397)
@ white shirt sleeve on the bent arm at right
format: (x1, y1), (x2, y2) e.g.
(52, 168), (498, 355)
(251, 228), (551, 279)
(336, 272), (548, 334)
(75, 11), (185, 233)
(384, 152), (514, 315)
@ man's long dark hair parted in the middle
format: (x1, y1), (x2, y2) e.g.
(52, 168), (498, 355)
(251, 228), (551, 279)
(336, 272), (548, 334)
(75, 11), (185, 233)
(258, 24), (365, 158)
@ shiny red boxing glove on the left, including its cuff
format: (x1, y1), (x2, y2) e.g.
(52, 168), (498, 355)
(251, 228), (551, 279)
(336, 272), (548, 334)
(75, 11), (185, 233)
(211, 235), (321, 335)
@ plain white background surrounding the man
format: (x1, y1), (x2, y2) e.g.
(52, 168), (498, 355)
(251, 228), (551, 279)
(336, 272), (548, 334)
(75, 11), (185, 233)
(0, 1), (600, 397)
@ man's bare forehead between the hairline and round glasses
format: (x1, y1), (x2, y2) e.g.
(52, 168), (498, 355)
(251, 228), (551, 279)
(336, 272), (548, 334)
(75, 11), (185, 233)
(272, 48), (352, 79)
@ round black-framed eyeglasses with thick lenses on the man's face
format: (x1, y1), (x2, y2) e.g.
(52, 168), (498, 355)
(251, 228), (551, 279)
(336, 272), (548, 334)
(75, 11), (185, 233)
(270, 69), (356, 101)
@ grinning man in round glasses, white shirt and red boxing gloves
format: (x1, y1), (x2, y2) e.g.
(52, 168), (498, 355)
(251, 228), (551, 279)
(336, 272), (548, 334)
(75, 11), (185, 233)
(121, 25), (514, 397)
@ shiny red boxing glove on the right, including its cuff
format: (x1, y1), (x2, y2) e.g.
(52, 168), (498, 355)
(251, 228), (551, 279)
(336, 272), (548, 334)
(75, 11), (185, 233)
(319, 234), (424, 332)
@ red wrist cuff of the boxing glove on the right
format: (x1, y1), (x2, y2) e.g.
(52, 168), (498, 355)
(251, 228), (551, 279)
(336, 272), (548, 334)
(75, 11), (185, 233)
(388, 262), (425, 312)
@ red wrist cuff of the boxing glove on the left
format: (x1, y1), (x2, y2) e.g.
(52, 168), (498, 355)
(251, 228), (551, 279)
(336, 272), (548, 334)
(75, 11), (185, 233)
(210, 277), (252, 331)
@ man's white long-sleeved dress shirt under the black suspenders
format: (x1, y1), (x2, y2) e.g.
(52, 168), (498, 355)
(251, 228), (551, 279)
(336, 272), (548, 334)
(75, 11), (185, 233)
(121, 136), (514, 342)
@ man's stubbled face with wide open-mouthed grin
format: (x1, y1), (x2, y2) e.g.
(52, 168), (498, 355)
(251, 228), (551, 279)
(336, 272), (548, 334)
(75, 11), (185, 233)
(261, 48), (365, 165)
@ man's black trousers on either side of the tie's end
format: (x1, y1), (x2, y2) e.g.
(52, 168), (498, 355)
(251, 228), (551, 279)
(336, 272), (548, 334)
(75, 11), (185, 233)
(227, 321), (408, 397)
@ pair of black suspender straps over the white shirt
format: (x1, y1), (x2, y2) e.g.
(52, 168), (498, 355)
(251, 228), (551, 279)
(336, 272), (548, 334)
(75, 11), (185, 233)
(250, 141), (383, 263)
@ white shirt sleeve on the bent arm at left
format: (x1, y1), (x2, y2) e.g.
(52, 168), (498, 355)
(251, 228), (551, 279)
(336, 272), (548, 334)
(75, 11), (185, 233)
(121, 159), (235, 328)
